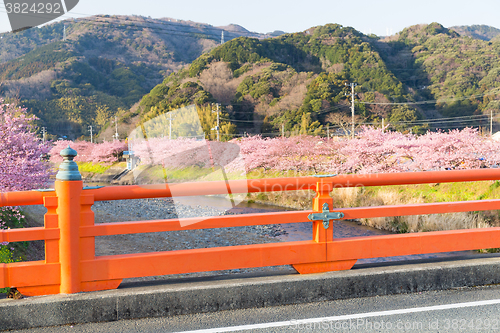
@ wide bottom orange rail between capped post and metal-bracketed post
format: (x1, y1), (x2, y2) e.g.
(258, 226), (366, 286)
(82, 241), (326, 281)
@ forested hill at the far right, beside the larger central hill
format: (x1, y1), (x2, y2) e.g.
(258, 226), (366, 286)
(381, 23), (500, 125)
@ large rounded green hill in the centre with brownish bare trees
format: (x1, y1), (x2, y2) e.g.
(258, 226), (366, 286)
(140, 24), (410, 133)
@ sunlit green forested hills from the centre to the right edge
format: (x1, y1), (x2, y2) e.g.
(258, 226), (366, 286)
(140, 23), (500, 133)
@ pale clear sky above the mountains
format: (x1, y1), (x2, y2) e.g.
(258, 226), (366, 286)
(0, 0), (500, 36)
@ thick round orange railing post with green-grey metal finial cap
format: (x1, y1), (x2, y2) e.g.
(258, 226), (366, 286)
(55, 146), (83, 294)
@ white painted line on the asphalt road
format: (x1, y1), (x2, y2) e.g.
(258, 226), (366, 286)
(179, 299), (500, 333)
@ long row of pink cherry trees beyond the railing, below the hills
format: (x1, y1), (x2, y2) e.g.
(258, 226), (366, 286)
(51, 127), (500, 174)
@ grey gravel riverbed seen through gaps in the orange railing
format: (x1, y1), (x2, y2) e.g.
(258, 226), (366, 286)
(21, 185), (476, 282)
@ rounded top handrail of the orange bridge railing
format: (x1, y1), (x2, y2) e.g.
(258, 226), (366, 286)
(0, 168), (500, 207)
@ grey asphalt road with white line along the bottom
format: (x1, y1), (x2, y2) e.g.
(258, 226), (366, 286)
(12, 286), (500, 333)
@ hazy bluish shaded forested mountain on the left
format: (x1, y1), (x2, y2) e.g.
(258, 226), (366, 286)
(0, 16), (274, 138)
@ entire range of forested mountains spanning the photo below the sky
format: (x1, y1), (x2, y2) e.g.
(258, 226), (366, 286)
(0, 16), (500, 138)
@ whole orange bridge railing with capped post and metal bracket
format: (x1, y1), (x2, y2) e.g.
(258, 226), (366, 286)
(0, 149), (500, 296)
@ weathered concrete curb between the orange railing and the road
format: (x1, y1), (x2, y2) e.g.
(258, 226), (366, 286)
(0, 255), (500, 330)
